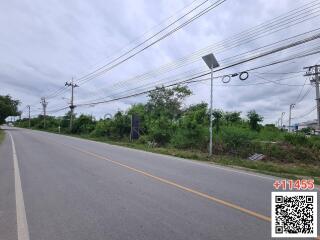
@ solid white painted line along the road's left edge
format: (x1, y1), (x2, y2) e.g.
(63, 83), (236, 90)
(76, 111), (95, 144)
(9, 133), (30, 240)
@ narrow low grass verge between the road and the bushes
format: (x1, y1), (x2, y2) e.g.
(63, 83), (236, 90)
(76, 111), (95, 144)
(61, 134), (320, 185)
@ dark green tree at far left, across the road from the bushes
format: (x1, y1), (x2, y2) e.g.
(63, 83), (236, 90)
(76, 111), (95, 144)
(0, 95), (20, 124)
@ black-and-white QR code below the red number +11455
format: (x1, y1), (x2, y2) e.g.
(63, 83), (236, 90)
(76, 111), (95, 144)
(271, 192), (317, 238)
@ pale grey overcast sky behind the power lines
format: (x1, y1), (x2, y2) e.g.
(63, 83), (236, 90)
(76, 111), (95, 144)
(0, 0), (320, 123)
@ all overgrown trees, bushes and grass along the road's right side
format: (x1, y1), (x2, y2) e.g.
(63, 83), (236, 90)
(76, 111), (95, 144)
(16, 86), (320, 180)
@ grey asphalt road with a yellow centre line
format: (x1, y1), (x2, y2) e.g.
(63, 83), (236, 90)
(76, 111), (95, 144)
(0, 128), (318, 240)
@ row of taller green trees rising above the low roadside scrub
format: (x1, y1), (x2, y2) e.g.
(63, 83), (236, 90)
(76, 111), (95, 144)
(17, 86), (263, 149)
